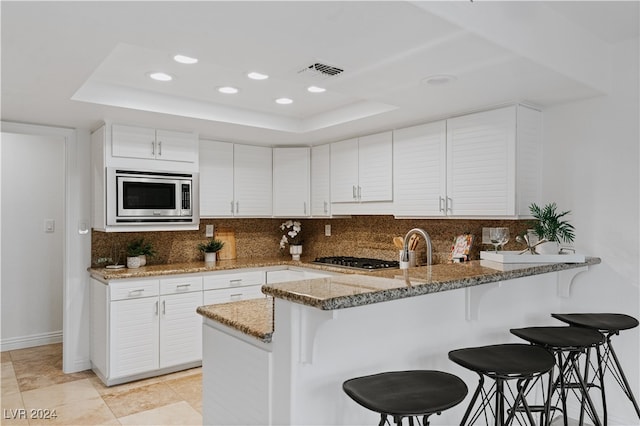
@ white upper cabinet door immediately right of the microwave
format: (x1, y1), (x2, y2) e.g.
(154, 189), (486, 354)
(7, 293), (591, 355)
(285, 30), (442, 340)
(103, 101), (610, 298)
(200, 140), (235, 217)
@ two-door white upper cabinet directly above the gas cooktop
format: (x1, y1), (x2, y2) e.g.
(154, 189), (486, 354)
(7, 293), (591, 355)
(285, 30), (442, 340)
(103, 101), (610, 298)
(331, 132), (393, 203)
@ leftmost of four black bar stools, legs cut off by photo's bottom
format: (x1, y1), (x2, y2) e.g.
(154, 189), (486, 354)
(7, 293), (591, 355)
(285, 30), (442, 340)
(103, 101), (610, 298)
(342, 370), (468, 426)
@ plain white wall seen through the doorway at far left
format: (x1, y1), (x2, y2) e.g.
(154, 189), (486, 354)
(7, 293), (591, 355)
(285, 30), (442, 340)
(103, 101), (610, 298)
(0, 133), (65, 350)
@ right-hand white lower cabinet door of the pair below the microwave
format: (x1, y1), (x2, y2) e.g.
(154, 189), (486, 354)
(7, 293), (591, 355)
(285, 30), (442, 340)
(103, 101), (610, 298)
(160, 291), (202, 368)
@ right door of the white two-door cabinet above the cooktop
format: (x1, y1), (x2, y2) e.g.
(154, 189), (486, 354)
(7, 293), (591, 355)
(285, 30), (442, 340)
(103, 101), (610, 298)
(358, 132), (393, 202)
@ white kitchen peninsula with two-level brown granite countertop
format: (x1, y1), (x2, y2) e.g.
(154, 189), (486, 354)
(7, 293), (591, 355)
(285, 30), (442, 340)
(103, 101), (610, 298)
(198, 258), (600, 425)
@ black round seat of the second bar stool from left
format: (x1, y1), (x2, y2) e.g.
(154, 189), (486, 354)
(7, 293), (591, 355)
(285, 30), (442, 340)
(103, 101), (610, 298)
(449, 343), (555, 377)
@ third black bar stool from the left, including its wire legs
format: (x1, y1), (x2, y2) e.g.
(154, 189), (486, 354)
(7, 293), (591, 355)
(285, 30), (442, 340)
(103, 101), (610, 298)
(511, 327), (604, 426)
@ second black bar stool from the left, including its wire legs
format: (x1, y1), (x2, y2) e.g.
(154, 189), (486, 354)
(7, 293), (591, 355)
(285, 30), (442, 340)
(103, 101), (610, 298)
(449, 344), (555, 426)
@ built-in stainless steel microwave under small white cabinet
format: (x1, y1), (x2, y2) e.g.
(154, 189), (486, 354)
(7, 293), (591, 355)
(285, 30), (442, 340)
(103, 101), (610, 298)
(106, 168), (199, 225)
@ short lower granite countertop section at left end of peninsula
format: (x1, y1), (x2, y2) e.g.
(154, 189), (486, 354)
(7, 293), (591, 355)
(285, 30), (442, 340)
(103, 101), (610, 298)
(197, 297), (273, 343)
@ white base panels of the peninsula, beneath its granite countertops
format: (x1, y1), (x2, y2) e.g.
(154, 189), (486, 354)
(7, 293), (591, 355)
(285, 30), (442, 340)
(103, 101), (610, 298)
(203, 273), (562, 425)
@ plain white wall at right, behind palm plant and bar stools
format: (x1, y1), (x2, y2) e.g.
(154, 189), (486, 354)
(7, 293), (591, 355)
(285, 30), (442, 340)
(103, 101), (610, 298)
(543, 39), (640, 425)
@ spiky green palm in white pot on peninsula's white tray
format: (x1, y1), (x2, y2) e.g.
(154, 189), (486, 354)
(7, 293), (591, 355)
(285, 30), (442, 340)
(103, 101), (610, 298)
(529, 203), (575, 254)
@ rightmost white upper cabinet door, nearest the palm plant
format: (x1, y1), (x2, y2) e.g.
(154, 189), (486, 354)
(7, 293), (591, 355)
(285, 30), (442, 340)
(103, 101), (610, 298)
(447, 106), (516, 216)
